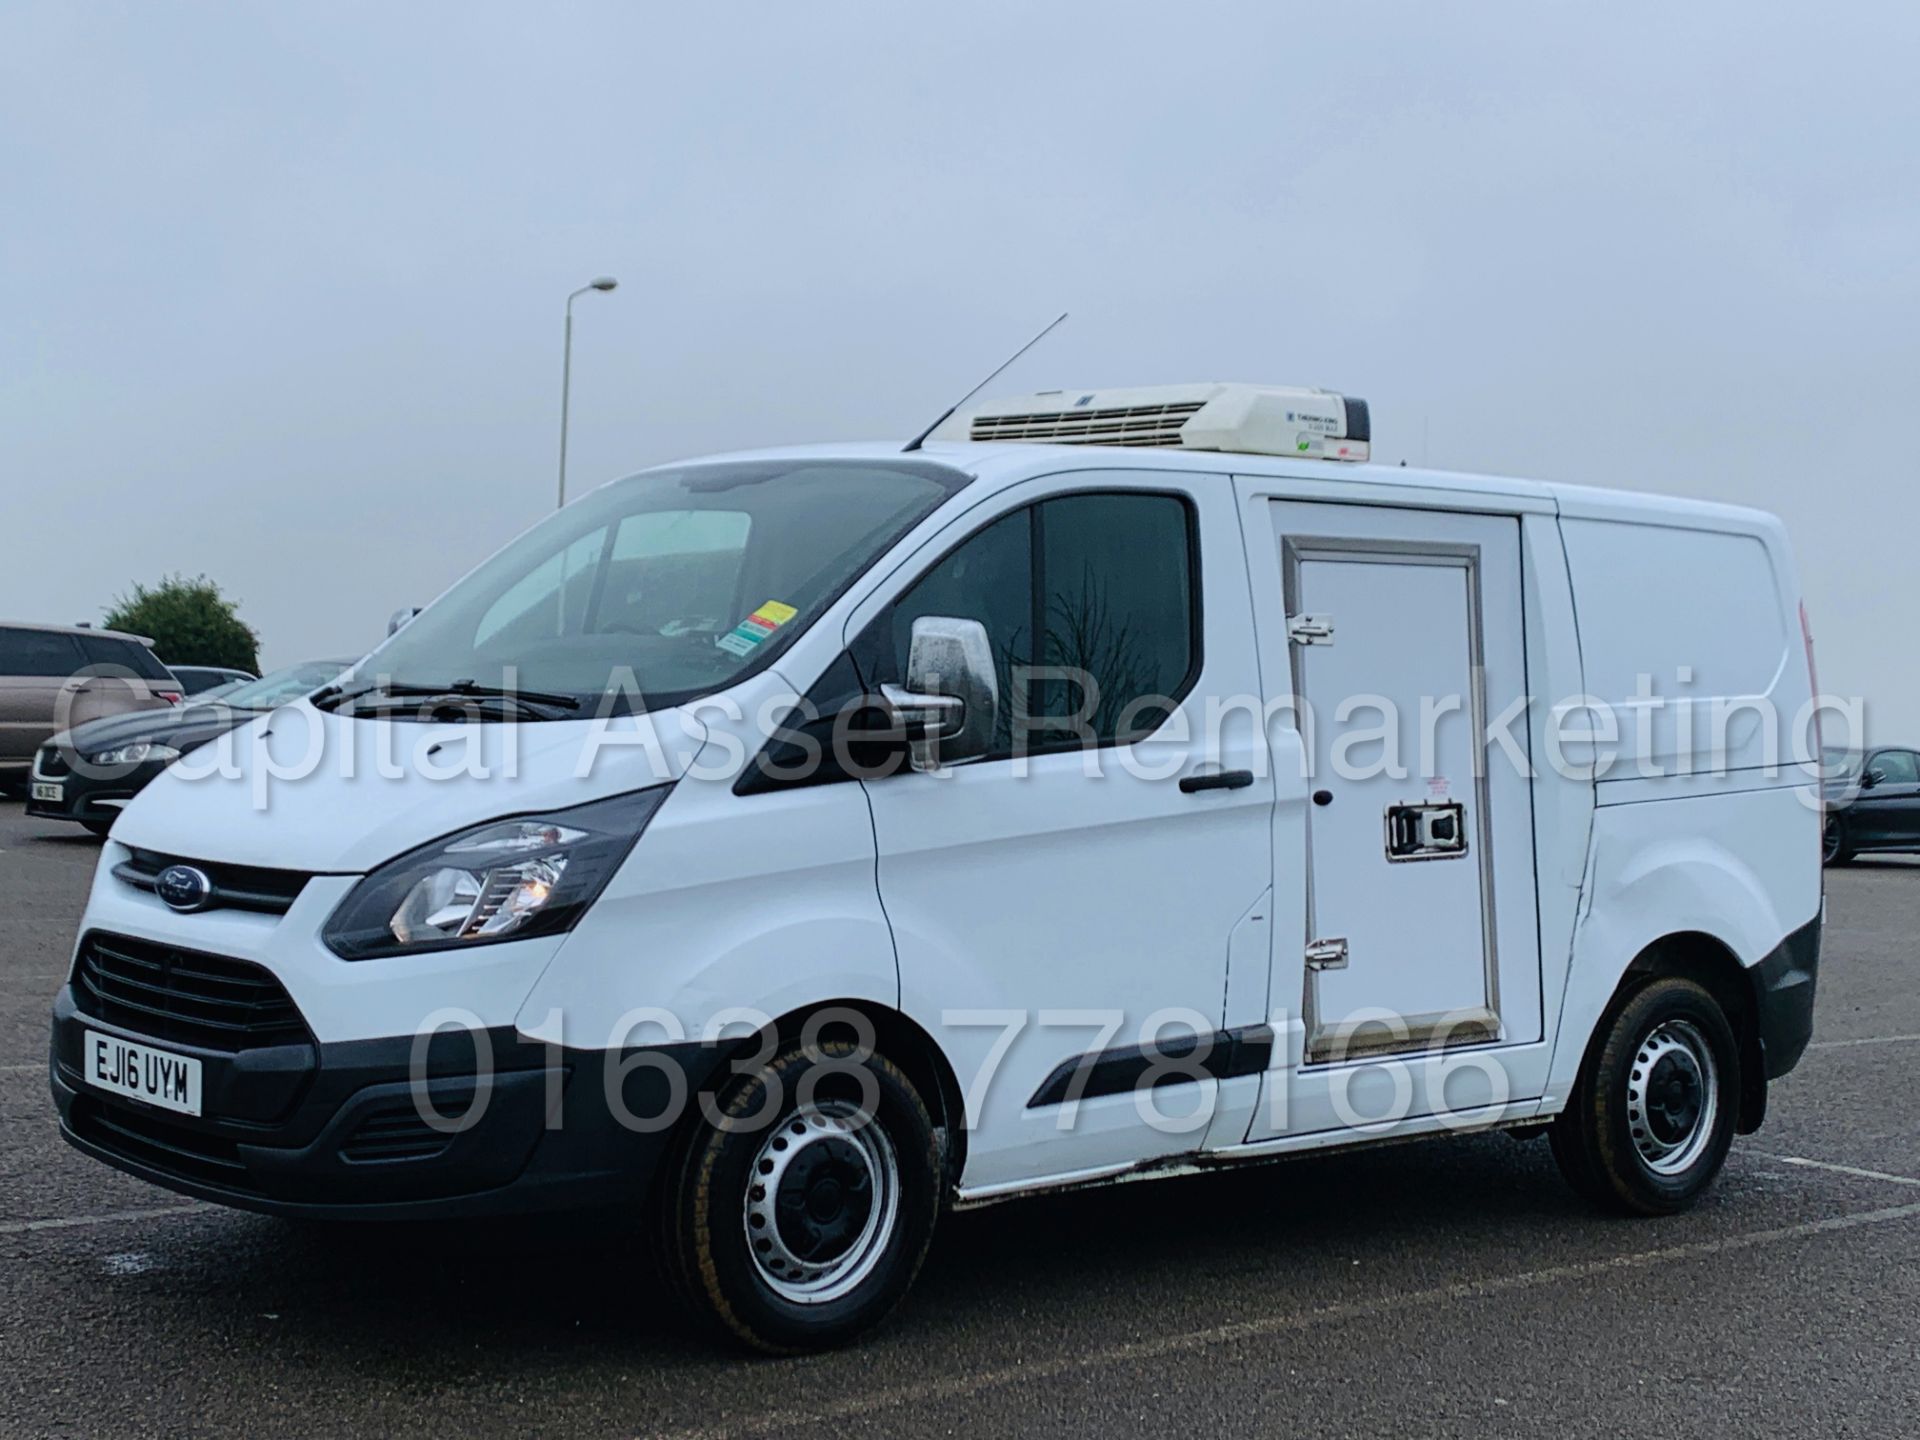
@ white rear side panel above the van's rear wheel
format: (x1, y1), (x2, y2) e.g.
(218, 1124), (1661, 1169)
(1542, 503), (1822, 1110)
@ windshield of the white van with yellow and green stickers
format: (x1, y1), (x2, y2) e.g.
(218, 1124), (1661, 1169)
(357, 459), (968, 714)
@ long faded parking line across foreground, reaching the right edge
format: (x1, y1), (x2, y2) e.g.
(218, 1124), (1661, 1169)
(668, 1204), (1920, 1440)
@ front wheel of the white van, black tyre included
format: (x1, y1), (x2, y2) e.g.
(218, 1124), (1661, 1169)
(657, 1041), (941, 1354)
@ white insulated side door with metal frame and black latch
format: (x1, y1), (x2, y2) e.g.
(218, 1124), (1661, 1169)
(1250, 501), (1542, 1139)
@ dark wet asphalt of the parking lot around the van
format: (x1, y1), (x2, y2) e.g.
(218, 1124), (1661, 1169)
(0, 801), (1920, 1436)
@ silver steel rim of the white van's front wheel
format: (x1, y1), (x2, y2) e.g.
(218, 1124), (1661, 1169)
(743, 1100), (900, 1306)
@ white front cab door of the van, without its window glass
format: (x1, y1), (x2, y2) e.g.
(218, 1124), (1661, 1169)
(847, 470), (1271, 1194)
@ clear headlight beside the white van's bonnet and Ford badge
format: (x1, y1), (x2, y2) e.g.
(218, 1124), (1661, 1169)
(323, 785), (672, 960)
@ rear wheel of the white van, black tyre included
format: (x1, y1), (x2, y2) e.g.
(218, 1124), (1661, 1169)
(1551, 979), (1740, 1215)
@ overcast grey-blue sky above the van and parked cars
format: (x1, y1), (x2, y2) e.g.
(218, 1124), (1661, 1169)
(0, 0), (1920, 739)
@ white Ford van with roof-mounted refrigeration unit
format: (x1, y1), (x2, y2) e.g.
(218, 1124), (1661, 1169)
(52, 384), (1822, 1352)
